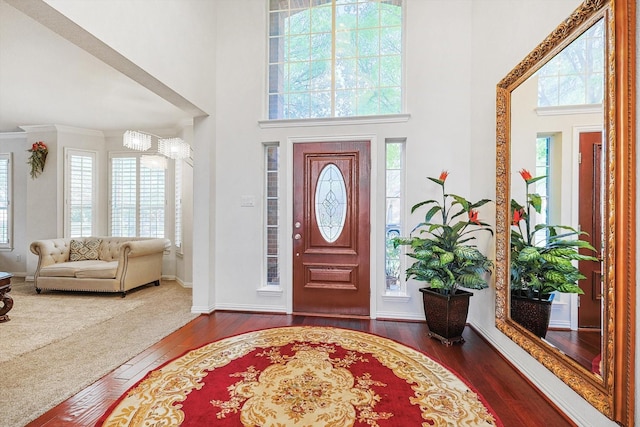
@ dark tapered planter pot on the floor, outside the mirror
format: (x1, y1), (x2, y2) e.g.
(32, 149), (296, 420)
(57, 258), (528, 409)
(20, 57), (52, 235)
(419, 288), (473, 346)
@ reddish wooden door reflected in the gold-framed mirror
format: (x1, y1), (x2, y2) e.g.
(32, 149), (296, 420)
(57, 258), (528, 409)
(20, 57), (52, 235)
(578, 132), (603, 328)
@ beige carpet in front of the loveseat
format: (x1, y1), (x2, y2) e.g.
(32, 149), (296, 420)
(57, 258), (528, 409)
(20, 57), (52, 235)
(0, 278), (197, 427)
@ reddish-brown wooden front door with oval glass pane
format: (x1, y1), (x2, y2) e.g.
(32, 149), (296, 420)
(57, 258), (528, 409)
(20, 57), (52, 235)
(292, 141), (370, 317)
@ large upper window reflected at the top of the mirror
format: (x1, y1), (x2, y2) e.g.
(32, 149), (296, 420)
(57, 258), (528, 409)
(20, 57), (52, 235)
(538, 20), (605, 107)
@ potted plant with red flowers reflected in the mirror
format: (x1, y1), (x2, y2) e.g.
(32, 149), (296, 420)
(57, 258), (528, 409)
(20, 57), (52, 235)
(510, 169), (598, 338)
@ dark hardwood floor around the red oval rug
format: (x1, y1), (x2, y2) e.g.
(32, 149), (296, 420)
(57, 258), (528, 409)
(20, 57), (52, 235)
(28, 312), (574, 427)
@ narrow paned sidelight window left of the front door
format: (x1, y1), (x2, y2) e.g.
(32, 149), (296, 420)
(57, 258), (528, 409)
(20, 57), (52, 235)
(264, 144), (280, 286)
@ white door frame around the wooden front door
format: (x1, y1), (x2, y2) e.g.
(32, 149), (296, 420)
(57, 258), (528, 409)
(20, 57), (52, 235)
(280, 134), (384, 319)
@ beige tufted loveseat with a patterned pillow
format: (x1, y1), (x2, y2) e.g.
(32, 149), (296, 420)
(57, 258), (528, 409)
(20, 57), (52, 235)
(31, 237), (170, 296)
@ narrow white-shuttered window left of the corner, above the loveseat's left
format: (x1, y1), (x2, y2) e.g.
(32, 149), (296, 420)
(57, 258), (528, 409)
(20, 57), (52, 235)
(64, 150), (96, 237)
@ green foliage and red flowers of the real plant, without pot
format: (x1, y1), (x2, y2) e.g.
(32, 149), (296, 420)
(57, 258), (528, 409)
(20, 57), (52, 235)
(394, 171), (493, 294)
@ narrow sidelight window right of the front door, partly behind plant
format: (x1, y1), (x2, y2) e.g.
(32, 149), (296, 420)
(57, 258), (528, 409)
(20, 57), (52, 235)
(384, 140), (404, 292)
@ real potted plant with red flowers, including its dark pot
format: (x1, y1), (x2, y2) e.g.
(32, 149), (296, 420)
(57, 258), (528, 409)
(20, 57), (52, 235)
(394, 171), (493, 345)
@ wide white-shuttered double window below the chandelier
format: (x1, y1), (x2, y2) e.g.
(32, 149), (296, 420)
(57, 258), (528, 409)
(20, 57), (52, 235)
(110, 154), (166, 237)
